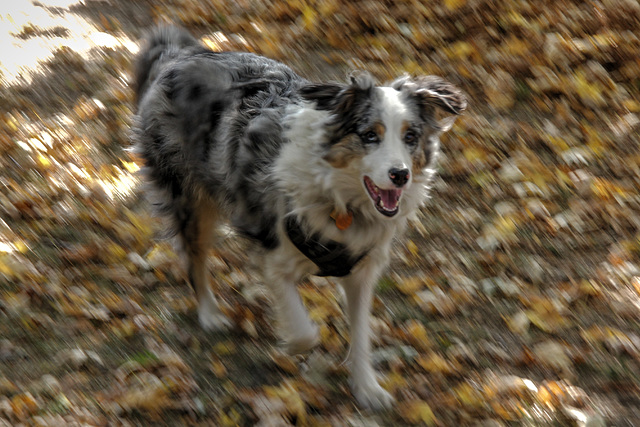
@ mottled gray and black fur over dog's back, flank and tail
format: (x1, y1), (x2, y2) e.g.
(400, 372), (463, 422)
(134, 28), (306, 248)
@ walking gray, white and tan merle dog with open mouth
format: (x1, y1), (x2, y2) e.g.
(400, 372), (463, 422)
(133, 27), (467, 409)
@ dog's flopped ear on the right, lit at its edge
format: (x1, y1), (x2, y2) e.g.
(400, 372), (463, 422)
(391, 76), (467, 132)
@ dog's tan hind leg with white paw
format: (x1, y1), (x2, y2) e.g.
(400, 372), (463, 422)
(177, 203), (231, 331)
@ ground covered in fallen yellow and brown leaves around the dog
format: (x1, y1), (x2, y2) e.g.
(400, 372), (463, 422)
(0, 0), (640, 426)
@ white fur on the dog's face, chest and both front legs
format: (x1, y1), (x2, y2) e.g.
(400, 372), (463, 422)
(266, 88), (433, 409)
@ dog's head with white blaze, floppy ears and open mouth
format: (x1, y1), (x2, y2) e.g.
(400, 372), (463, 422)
(301, 73), (467, 217)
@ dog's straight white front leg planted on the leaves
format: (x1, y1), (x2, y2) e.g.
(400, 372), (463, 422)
(343, 262), (394, 409)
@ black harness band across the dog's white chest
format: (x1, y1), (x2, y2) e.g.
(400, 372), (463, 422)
(284, 215), (367, 277)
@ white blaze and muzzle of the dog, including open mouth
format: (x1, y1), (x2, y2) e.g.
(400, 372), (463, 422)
(362, 87), (412, 216)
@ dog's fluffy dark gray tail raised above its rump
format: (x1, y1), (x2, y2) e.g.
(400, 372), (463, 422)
(134, 25), (201, 103)
